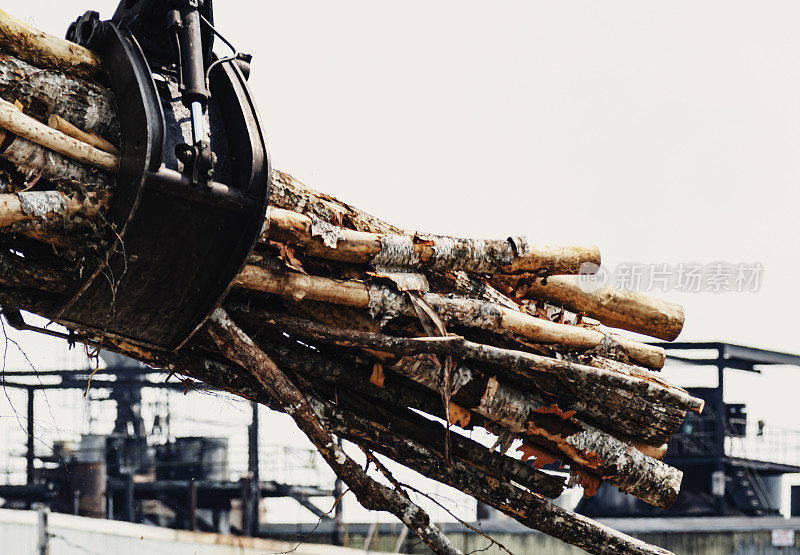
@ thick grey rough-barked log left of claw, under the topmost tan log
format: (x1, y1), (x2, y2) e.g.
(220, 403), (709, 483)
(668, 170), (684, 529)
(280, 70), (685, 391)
(0, 52), (119, 142)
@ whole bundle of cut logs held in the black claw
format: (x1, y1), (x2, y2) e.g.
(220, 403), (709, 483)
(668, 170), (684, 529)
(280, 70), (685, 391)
(0, 11), (703, 553)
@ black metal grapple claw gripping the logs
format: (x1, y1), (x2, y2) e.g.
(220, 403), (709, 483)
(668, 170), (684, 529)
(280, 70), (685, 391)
(58, 0), (270, 351)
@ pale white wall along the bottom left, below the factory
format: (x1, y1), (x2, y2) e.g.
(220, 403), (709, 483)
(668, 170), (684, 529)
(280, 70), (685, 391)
(0, 509), (363, 555)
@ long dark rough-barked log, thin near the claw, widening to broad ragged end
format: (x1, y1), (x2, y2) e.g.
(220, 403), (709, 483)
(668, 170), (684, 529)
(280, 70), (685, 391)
(228, 305), (703, 447)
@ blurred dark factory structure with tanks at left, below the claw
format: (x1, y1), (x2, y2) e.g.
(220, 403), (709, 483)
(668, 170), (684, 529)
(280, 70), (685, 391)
(0, 352), (336, 539)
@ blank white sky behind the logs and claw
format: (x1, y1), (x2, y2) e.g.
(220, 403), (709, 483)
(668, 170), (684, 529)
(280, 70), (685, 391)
(8, 0), (800, 524)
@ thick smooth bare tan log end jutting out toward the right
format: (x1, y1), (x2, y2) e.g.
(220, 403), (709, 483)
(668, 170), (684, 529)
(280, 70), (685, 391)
(492, 274), (684, 341)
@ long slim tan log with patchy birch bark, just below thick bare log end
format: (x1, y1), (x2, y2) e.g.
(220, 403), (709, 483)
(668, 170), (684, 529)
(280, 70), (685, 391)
(234, 265), (666, 369)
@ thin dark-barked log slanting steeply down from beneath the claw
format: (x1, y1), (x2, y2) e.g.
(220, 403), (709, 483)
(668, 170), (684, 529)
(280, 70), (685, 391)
(208, 309), (461, 555)
